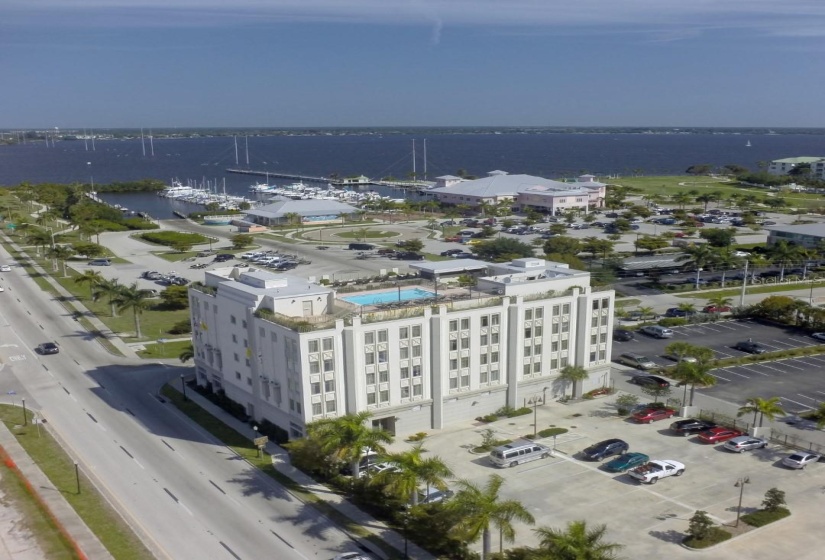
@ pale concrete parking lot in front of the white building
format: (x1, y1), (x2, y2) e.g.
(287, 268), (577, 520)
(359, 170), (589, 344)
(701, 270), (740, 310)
(416, 397), (825, 559)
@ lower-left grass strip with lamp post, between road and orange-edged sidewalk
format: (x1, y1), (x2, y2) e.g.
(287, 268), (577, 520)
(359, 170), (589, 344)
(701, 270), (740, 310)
(0, 405), (154, 560)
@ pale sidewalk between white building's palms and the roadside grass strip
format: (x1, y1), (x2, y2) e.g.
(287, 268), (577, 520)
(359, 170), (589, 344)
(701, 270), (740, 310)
(170, 384), (435, 560)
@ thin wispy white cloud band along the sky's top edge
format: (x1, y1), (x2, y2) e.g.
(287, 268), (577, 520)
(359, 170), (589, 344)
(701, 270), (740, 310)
(0, 0), (825, 38)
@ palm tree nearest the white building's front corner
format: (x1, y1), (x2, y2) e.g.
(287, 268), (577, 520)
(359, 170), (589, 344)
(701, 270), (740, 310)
(307, 411), (392, 478)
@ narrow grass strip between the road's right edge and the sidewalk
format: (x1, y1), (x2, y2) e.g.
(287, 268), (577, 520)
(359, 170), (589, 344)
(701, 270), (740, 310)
(161, 385), (398, 558)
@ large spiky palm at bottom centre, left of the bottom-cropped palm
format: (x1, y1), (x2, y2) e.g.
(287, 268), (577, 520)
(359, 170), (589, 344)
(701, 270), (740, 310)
(449, 474), (536, 560)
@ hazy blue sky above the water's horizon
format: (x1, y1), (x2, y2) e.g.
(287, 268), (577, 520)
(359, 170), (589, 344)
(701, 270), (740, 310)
(0, 0), (825, 128)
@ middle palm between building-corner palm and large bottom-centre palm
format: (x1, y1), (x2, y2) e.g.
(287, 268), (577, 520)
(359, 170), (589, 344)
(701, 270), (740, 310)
(373, 443), (453, 506)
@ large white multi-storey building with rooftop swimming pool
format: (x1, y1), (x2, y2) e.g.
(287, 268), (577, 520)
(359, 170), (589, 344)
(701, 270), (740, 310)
(189, 258), (614, 438)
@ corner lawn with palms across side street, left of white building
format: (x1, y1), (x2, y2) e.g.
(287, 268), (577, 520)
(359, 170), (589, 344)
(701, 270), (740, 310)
(55, 270), (189, 342)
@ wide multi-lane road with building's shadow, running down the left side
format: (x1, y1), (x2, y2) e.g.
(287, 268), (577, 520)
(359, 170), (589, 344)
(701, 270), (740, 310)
(0, 249), (360, 560)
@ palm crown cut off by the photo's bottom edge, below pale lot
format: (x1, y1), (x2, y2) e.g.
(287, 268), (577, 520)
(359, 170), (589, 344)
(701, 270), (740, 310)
(535, 521), (623, 560)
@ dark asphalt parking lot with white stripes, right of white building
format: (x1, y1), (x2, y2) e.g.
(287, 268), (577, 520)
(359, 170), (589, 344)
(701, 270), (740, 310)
(613, 320), (825, 412)
